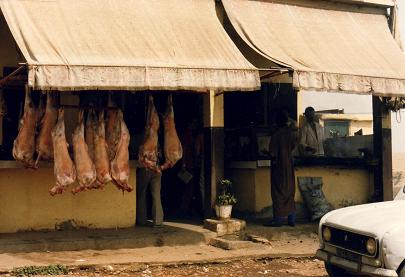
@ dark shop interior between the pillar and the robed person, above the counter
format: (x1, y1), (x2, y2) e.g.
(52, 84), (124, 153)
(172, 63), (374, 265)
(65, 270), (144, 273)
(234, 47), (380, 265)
(224, 83), (297, 163)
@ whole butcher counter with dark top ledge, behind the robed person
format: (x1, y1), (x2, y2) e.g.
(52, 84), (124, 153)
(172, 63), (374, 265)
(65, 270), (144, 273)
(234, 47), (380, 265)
(226, 157), (374, 217)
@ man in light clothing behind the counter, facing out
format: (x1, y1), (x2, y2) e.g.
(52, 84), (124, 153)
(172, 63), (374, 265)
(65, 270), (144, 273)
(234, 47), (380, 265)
(299, 107), (324, 156)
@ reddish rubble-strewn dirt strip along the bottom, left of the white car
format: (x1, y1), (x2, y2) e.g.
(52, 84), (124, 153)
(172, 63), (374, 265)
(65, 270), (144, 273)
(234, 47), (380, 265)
(41, 258), (327, 277)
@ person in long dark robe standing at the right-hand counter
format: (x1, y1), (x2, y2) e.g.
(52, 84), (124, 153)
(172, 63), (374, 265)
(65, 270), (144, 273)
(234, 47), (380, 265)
(264, 112), (297, 227)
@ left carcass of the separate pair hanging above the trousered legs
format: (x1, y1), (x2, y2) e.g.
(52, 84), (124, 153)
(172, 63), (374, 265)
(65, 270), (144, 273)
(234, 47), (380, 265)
(138, 95), (161, 172)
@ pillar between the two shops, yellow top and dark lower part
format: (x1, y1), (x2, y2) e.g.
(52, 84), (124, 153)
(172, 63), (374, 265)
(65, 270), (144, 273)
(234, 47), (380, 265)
(203, 90), (224, 218)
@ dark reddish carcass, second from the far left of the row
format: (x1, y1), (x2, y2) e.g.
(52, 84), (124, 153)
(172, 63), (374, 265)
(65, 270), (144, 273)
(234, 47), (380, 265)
(35, 93), (58, 166)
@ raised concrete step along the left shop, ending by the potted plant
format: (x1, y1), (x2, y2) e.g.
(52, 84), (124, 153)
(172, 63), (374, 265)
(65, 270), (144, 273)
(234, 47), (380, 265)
(0, 222), (216, 253)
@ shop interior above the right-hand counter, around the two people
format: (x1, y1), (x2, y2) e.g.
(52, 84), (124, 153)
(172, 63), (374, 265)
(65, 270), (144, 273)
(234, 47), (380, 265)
(224, 82), (373, 165)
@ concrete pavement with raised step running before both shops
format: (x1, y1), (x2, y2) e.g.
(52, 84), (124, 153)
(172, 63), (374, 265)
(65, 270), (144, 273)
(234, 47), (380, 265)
(0, 219), (322, 276)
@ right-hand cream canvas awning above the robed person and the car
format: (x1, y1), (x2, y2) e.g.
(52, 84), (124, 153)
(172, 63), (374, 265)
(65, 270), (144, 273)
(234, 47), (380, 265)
(222, 0), (405, 96)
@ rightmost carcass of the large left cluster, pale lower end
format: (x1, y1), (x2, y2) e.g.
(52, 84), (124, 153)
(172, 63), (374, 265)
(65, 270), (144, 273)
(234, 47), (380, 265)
(111, 111), (132, 192)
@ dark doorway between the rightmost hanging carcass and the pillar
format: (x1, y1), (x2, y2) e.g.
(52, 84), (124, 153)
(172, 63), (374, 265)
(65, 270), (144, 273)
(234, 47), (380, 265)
(148, 92), (205, 220)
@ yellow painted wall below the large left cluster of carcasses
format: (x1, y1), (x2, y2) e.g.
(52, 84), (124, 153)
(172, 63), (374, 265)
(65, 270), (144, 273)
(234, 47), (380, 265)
(0, 168), (136, 233)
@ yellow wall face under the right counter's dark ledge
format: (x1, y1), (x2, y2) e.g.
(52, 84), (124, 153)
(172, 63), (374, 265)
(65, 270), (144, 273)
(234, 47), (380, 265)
(227, 166), (373, 213)
